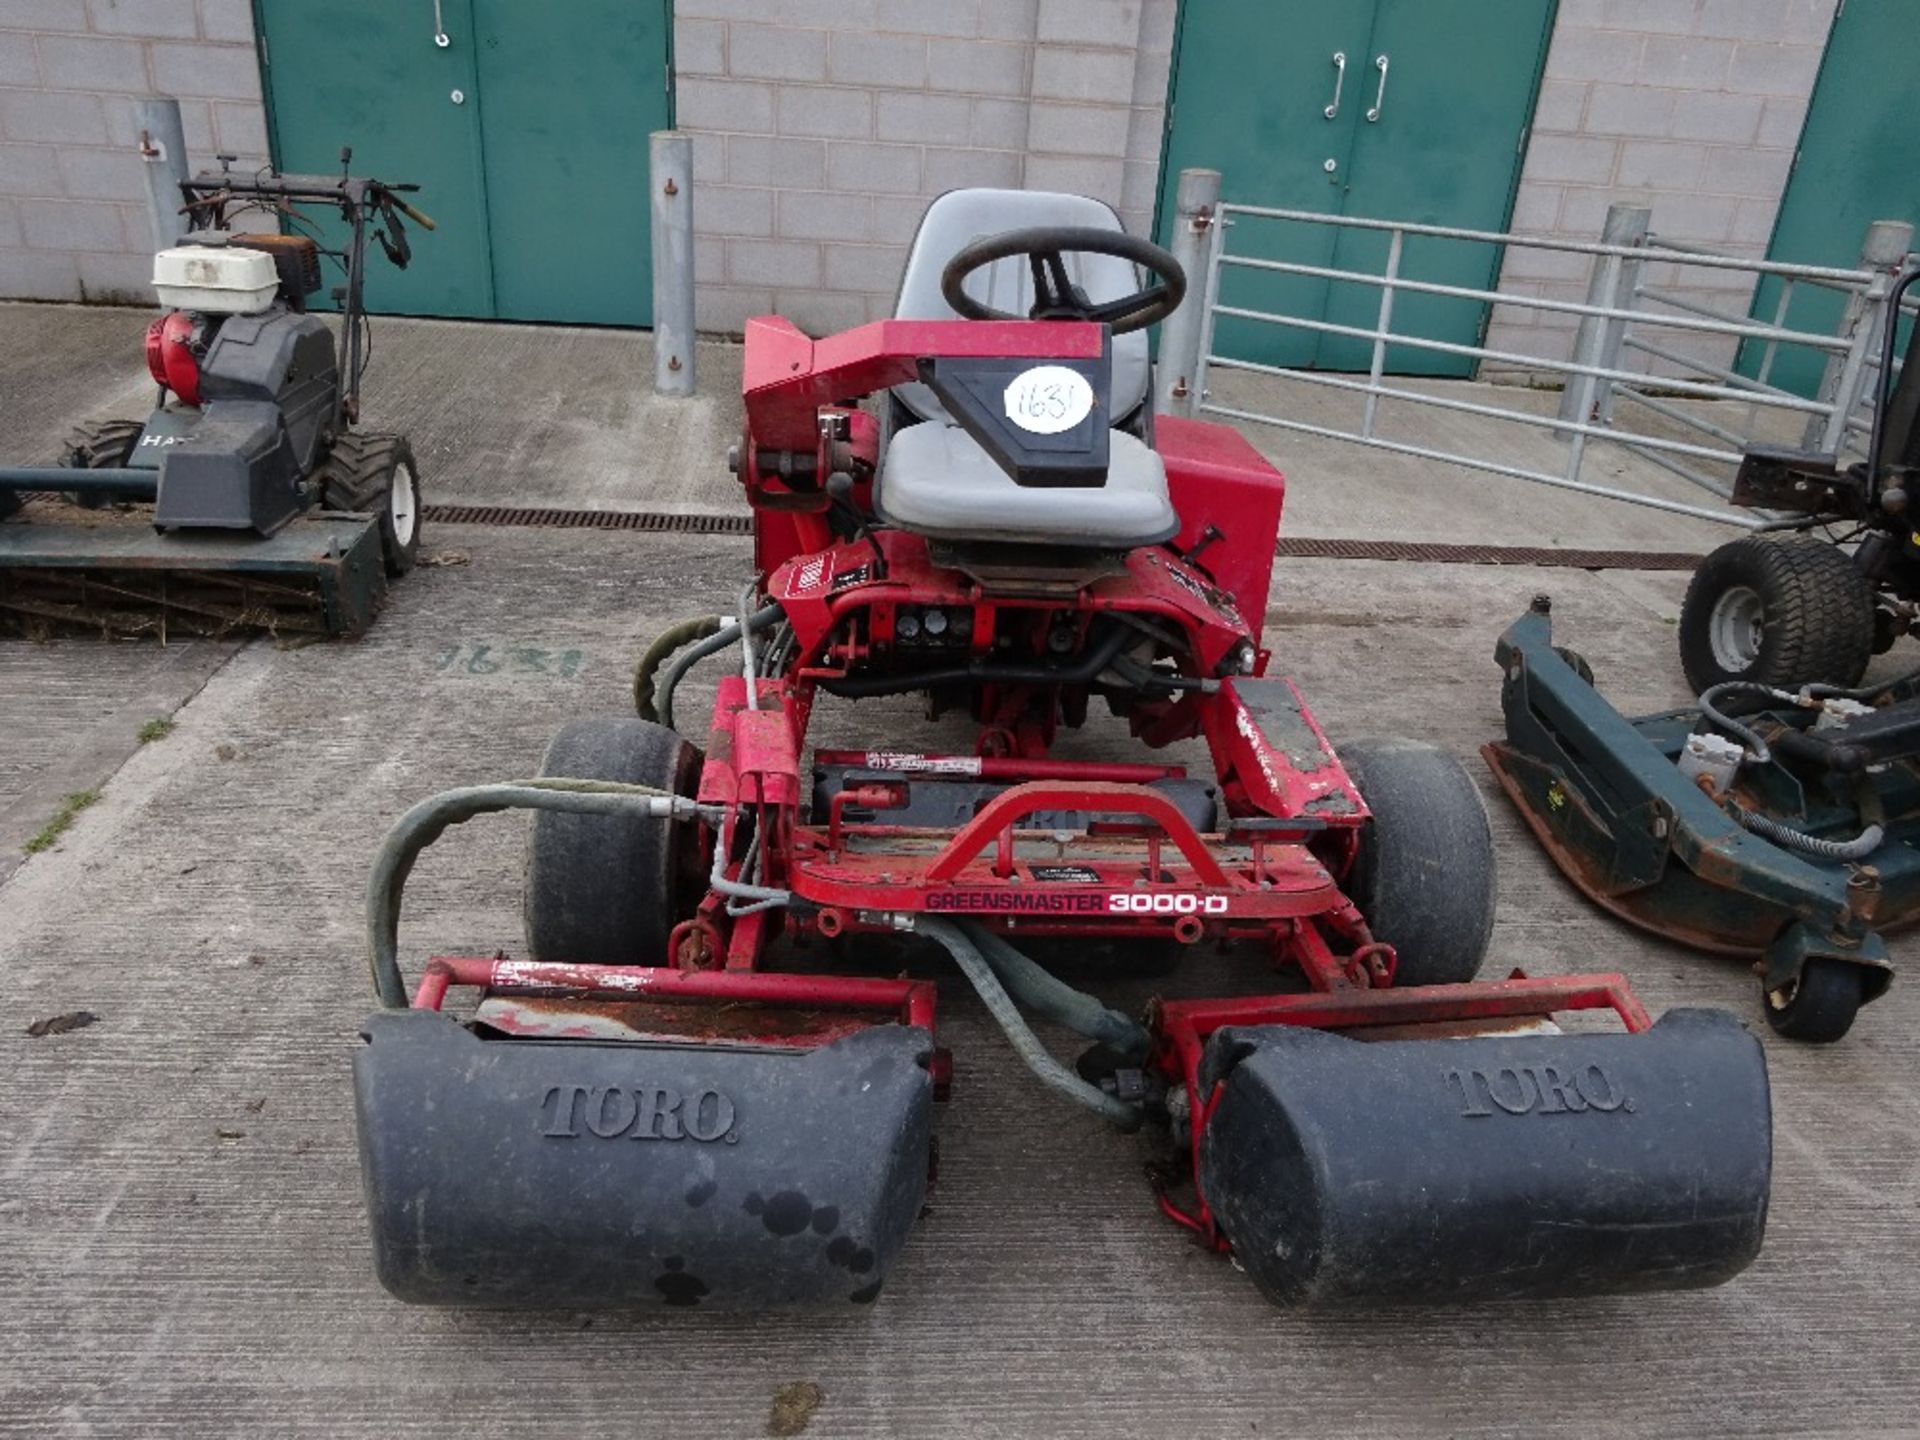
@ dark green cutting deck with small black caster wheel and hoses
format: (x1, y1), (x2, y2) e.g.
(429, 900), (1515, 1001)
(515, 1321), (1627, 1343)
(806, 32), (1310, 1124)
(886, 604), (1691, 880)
(1482, 591), (1920, 1041)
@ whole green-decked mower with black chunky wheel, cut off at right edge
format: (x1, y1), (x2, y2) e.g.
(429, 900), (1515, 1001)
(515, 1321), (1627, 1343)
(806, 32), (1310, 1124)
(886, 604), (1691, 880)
(1484, 271), (1920, 1041)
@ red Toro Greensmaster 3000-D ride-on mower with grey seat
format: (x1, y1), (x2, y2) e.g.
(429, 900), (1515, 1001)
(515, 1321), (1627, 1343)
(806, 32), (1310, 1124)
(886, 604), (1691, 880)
(355, 192), (1770, 1308)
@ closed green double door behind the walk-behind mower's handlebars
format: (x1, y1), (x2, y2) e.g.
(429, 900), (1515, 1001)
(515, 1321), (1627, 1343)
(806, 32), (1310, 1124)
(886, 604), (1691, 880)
(255, 0), (670, 324)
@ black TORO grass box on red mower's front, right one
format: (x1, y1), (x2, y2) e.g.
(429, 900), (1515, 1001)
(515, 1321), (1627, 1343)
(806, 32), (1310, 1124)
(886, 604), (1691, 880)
(1200, 1010), (1772, 1304)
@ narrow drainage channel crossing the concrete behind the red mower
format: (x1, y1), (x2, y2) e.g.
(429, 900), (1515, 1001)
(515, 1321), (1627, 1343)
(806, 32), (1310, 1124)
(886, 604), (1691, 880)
(422, 505), (1701, 570)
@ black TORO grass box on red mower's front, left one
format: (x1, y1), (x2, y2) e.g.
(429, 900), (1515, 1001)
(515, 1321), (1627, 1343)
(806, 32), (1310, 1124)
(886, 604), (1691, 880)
(353, 1010), (933, 1309)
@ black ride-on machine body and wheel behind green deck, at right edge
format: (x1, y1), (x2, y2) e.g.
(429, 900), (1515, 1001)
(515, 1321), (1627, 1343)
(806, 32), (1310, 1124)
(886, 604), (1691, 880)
(1680, 269), (1920, 691)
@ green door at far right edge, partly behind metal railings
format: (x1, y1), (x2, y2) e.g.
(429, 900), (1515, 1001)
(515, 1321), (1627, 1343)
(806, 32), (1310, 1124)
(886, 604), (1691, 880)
(1740, 0), (1920, 396)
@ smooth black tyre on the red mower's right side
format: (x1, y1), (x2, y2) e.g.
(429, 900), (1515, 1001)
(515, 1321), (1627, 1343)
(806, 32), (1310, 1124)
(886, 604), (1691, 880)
(1340, 739), (1496, 985)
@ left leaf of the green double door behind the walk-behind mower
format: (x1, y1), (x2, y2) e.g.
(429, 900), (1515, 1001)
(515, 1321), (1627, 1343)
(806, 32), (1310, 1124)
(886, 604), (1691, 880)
(257, 0), (493, 317)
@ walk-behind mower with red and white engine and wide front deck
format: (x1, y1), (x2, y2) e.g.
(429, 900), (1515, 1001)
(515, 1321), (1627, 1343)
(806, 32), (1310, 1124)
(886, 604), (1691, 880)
(0, 150), (432, 634)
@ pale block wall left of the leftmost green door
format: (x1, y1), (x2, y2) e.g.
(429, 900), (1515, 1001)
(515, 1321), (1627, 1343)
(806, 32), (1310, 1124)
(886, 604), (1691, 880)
(0, 0), (267, 305)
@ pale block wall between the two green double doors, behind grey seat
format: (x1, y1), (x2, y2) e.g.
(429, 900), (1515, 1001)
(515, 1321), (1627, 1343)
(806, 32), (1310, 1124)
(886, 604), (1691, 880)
(674, 0), (1175, 334)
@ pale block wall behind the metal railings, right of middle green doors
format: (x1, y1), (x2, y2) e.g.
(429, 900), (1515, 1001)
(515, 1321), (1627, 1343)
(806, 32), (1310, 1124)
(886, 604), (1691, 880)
(1488, 0), (1836, 372)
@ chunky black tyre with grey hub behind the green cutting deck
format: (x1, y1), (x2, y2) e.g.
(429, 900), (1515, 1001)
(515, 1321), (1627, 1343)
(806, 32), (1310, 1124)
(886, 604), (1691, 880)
(1680, 536), (1876, 693)
